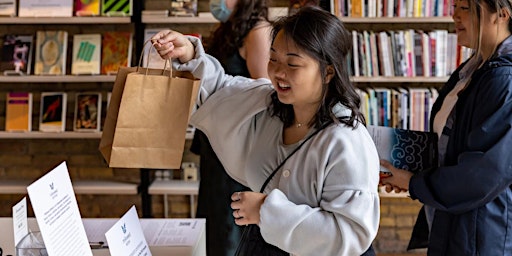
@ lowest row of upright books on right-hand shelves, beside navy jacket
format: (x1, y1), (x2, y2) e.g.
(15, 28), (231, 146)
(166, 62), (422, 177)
(357, 87), (439, 131)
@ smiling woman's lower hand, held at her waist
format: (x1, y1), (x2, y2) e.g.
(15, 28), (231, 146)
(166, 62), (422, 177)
(231, 191), (267, 226)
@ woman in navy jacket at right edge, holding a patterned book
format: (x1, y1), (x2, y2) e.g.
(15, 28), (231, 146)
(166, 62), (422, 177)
(382, 0), (512, 256)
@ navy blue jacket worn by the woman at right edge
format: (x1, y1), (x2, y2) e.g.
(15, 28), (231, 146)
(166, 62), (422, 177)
(409, 37), (512, 256)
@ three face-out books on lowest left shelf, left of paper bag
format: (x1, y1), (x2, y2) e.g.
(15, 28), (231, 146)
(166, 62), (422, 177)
(5, 92), (110, 132)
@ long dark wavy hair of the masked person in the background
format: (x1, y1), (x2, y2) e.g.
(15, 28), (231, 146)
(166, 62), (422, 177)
(207, 0), (269, 59)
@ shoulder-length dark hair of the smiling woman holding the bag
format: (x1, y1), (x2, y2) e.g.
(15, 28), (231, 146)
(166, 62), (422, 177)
(269, 7), (365, 128)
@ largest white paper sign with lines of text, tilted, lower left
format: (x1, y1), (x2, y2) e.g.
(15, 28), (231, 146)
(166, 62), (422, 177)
(27, 162), (92, 256)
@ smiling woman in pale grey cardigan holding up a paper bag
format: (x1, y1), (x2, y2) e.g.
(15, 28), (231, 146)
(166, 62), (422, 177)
(152, 7), (380, 255)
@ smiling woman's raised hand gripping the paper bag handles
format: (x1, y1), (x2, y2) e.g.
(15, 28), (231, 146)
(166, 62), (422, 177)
(151, 30), (195, 63)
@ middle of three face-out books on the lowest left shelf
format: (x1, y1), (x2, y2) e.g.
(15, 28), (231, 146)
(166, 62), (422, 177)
(39, 92), (67, 132)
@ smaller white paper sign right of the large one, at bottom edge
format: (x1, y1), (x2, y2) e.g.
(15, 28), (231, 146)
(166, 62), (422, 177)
(105, 206), (151, 256)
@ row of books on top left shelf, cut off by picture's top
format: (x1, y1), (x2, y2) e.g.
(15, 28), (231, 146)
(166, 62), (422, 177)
(0, 0), (133, 17)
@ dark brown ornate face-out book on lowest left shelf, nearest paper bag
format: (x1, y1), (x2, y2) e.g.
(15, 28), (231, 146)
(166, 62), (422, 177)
(73, 92), (101, 132)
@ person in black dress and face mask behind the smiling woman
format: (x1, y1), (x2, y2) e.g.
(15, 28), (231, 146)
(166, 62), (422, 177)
(191, 0), (271, 256)
